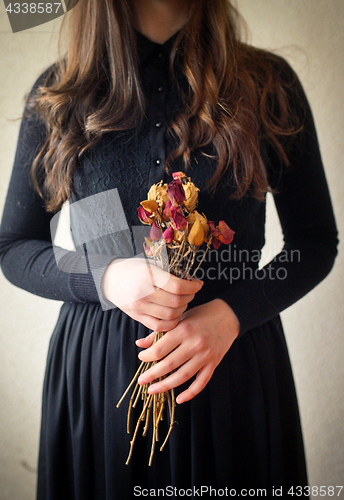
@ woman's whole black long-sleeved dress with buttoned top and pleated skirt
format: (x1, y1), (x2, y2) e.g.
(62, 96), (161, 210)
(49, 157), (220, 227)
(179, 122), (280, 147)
(0, 34), (337, 500)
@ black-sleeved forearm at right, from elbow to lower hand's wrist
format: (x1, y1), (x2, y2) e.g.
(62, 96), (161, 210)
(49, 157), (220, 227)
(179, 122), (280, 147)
(216, 234), (337, 335)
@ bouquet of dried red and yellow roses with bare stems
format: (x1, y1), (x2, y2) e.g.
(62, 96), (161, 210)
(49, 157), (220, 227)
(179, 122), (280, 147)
(117, 172), (234, 465)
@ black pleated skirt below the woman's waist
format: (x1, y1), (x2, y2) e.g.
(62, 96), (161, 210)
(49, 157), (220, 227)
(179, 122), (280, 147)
(37, 303), (307, 500)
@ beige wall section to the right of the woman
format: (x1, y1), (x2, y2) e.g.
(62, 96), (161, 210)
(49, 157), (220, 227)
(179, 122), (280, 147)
(238, 0), (344, 488)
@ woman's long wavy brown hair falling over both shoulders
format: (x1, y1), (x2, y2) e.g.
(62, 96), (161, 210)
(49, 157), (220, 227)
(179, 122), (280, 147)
(32, 0), (299, 211)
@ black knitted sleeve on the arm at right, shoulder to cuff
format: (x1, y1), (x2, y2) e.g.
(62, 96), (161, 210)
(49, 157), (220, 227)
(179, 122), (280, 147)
(217, 65), (338, 333)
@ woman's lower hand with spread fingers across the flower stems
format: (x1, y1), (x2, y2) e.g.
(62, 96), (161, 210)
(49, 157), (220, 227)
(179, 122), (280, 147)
(136, 299), (240, 403)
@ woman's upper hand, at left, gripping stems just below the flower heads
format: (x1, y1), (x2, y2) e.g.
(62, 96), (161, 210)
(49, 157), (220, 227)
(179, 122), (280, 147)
(101, 258), (203, 332)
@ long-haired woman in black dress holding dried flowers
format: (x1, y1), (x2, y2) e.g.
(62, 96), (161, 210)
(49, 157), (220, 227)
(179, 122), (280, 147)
(0, 0), (337, 500)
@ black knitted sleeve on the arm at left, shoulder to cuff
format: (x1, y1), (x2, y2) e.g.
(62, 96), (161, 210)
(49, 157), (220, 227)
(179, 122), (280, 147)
(0, 72), (99, 302)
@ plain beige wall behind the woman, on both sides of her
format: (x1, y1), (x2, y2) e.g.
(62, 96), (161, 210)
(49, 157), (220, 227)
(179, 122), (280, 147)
(0, 0), (344, 500)
